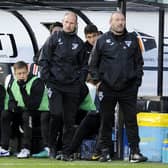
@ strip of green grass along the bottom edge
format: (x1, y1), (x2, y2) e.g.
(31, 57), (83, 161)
(0, 157), (168, 168)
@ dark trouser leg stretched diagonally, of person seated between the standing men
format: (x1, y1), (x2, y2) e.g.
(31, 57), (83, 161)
(69, 112), (100, 154)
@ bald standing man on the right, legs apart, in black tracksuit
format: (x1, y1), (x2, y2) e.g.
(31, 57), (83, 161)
(90, 12), (147, 162)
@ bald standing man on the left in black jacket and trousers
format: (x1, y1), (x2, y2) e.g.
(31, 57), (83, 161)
(39, 12), (88, 160)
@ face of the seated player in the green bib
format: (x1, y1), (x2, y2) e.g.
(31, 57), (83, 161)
(14, 68), (29, 81)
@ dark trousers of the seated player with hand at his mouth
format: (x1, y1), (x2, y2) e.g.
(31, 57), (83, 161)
(1, 111), (32, 149)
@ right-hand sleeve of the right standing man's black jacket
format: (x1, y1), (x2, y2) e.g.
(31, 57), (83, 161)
(135, 38), (144, 86)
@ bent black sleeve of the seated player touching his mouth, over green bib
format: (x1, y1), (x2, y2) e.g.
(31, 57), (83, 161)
(21, 78), (45, 110)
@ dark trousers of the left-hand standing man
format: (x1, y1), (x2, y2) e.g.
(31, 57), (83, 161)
(49, 89), (79, 153)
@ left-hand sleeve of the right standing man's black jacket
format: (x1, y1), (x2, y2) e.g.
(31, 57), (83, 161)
(89, 40), (101, 82)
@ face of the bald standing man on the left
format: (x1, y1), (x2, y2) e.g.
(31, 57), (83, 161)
(63, 14), (77, 33)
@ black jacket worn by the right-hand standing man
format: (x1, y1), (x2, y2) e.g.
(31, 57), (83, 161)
(90, 31), (143, 90)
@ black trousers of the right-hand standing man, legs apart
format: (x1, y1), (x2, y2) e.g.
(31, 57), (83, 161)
(98, 83), (140, 152)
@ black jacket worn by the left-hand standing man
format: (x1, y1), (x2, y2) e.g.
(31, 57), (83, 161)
(39, 31), (88, 85)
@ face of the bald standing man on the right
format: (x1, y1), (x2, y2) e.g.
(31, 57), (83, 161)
(110, 13), (125, 33)
